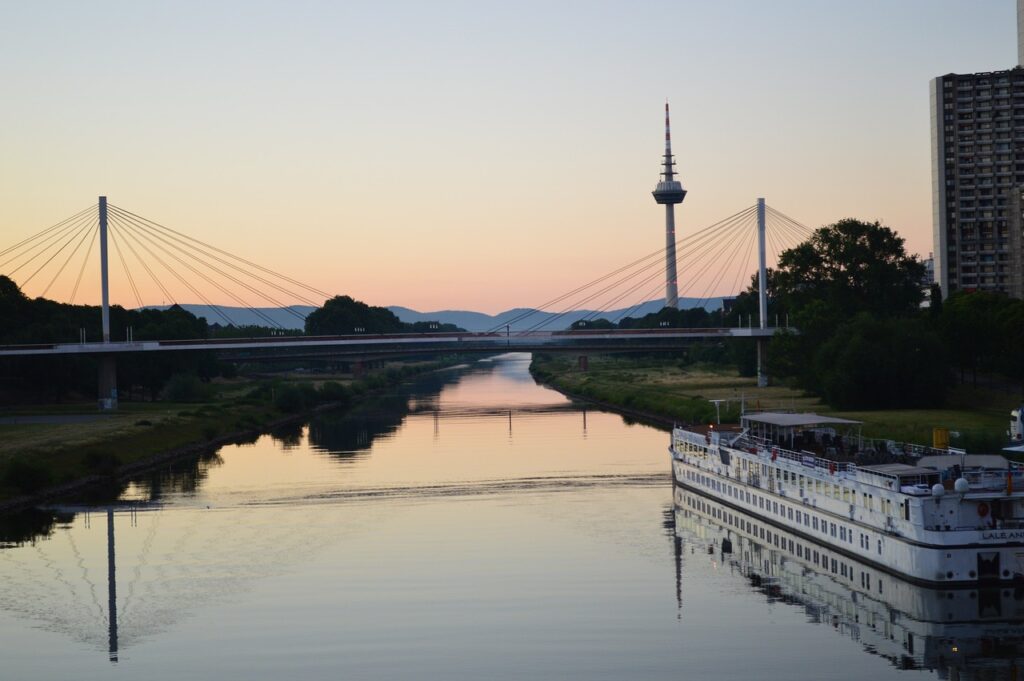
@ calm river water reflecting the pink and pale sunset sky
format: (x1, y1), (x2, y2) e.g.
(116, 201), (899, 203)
(0, 355), (1011, 680)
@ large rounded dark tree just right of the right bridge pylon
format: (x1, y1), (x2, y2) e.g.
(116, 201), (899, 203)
(745, 219), (947, 408)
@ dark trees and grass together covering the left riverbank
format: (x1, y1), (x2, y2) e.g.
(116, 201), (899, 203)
(0, 275), (471, 502)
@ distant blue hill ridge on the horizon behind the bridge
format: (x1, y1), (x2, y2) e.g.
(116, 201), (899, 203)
(152, 297), (722, 331)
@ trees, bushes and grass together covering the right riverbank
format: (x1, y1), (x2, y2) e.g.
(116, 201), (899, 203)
(532, 219), (1024, 451)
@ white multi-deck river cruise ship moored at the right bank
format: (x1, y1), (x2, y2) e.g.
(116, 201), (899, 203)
(670, 413), (1024, 585)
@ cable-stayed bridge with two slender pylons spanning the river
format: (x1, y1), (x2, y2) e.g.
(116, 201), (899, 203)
(0, 197), (811, 395)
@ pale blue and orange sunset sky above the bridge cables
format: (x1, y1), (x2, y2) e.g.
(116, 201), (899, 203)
(0, 0), (1017, 312)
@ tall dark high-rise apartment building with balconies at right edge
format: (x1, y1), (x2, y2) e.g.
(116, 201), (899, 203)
(931, 0), (1024, 296)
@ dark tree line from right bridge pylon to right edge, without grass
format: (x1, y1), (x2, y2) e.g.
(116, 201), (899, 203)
(733, 219), (1024, 409)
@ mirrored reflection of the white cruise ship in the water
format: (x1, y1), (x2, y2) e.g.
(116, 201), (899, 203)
(666, 486), (1024, 681)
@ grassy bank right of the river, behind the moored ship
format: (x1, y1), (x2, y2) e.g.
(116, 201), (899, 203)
(530, 355), (1020, 452)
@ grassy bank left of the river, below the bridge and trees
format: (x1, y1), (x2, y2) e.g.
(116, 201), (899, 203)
(0, 361), (452, 504)
